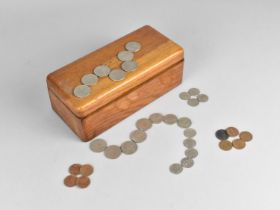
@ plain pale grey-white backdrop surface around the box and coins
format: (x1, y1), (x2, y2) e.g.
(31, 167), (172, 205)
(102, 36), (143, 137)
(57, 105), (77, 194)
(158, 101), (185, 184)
(0, 0), (280, 210)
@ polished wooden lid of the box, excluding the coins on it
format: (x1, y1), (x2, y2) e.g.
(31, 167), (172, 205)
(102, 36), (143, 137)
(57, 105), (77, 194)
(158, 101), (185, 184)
(47, 26), (183, 118)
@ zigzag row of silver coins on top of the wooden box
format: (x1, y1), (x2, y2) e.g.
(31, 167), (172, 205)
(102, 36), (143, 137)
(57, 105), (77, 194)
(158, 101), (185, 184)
(73, 41), (141, 98)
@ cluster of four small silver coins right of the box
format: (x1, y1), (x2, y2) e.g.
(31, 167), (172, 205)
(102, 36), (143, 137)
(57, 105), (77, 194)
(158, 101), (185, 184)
(179, 88), (209, 107)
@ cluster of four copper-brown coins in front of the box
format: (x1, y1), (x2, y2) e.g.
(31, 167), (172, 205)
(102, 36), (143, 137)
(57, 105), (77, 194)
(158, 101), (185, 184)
(64, 163), (94, 188)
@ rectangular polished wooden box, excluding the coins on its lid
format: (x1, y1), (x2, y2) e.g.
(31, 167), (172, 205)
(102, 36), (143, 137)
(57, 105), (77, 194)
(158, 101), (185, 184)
(47, 26), (184, 141)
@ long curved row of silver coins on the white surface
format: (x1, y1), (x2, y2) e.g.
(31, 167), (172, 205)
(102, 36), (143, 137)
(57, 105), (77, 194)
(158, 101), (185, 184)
(90, 113), (198, 174)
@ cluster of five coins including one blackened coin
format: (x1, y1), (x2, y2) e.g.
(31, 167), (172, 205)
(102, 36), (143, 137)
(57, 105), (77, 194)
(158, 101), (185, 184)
(215, 127), (253, 151)
